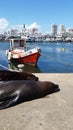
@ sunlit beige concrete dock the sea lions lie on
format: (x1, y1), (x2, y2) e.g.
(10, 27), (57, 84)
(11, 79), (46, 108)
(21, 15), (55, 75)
(0, 73), (73, 130)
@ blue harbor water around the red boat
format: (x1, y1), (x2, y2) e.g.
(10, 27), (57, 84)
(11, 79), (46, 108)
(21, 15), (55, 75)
(0, 42), (73, 73)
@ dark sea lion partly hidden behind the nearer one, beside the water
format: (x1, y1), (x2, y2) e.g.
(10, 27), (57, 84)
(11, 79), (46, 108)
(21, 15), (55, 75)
(0, 70), (38, 81)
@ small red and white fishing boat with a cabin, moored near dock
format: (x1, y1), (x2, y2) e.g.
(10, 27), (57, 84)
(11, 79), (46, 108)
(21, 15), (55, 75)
(6, 39), (41, 66)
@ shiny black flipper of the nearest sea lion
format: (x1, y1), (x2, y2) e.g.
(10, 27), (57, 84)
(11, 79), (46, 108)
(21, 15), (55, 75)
(0, 96), (18, 110)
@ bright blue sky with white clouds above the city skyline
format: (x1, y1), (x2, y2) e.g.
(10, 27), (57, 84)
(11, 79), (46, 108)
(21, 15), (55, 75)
(0, 0), (73, 33)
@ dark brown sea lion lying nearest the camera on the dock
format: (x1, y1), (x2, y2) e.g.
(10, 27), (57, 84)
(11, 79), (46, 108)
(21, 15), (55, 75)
(0, 80), (59, 110)
